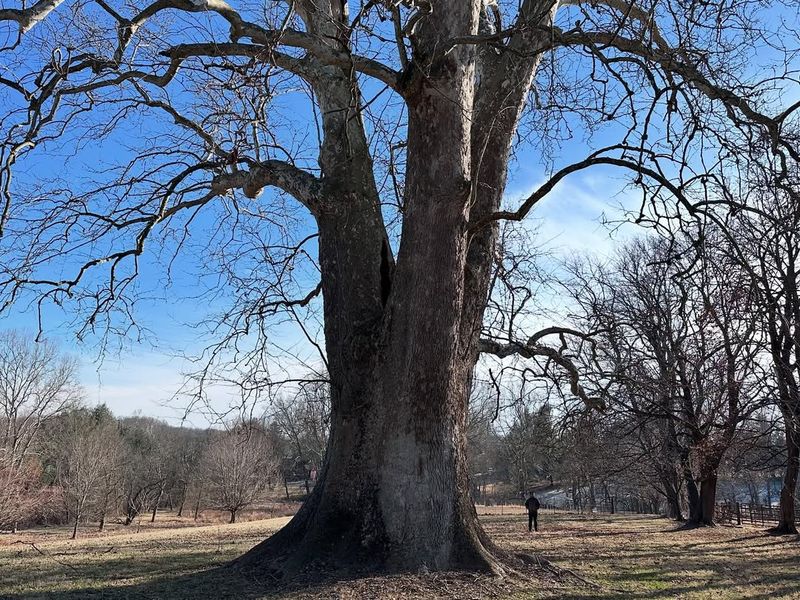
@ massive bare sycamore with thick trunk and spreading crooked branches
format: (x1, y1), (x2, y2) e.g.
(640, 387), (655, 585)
(0, 0), (797, 575)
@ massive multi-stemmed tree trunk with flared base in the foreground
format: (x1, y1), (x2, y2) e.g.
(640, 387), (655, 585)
(228, 0), (552, 577)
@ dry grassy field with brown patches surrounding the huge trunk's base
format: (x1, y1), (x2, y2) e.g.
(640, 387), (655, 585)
(0, 508), (800, 600)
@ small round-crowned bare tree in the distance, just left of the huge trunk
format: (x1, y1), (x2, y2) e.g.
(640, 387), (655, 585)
(202, 424), (278, 523)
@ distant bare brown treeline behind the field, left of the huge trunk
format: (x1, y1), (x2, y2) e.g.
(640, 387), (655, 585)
(0, 332), (329, 536)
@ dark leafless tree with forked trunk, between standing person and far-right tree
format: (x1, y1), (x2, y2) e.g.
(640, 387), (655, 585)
(577, 239), (766, 524)
